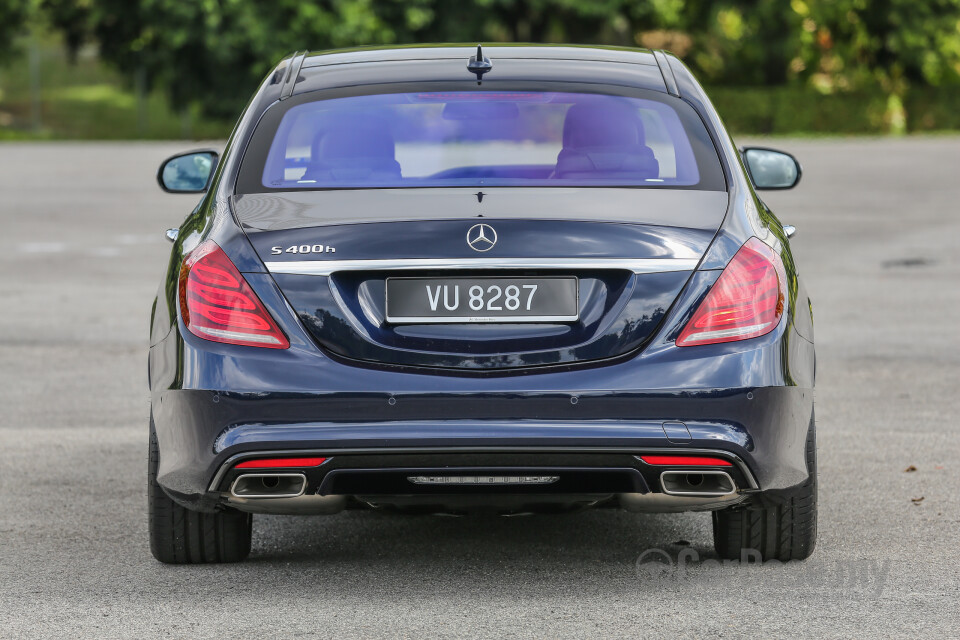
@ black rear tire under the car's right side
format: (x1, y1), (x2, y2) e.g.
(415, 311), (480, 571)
(713, 418), (817, 562)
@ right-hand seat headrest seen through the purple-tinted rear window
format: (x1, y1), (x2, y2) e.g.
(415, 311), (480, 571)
(563, 98), (644, 149)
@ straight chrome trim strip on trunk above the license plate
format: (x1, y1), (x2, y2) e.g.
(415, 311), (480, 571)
(263, 258), (700, 276)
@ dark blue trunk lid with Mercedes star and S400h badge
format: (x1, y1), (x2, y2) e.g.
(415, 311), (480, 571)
(232, 188), (727, 370)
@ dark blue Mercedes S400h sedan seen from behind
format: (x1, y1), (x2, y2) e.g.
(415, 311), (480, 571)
(149, 45), (817, 563)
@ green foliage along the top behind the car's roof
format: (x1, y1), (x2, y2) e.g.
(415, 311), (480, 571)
(0, 0), (960, 132)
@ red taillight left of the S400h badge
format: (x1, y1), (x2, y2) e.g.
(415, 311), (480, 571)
(180, 240), (290, 349)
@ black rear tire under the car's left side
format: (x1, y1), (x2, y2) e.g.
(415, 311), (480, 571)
(147, 418), (253, 564)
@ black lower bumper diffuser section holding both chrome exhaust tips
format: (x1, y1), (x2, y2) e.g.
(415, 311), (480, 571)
(221, 450), (755, 514)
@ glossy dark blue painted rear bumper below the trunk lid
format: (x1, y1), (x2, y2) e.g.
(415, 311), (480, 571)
(150, 318), (813, 509)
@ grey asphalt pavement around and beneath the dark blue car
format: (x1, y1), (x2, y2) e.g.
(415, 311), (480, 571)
(0, 137), (960, 638)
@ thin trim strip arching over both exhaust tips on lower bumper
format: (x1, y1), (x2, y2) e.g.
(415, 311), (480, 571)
(207, 446), (760, 491)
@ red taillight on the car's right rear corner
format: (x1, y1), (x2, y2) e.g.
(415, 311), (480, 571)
(677, 238), (786, 347)
